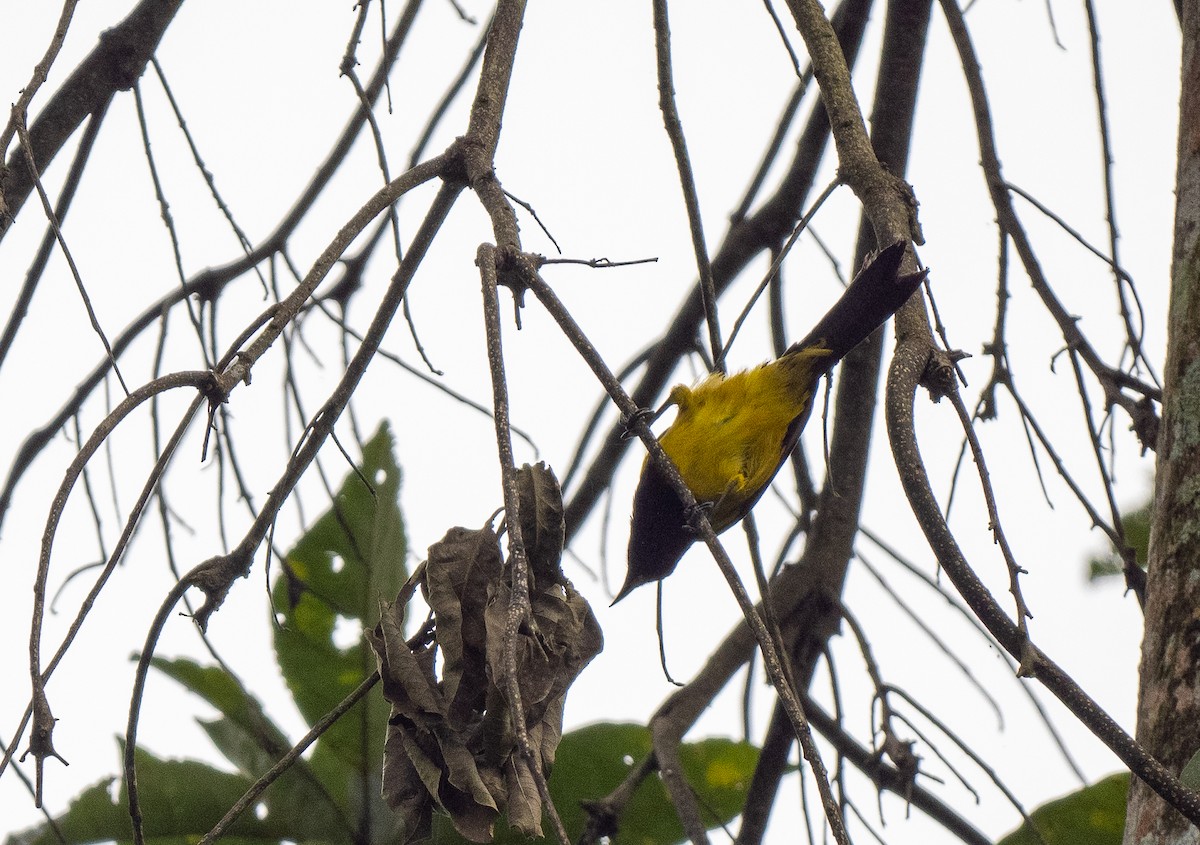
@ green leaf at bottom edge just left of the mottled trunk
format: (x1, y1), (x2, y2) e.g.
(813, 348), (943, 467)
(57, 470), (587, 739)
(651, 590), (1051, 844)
(998, 772), (1129, 845)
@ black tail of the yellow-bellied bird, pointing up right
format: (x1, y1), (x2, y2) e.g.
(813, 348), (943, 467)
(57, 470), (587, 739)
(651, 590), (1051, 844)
(784, 241), (926, 376)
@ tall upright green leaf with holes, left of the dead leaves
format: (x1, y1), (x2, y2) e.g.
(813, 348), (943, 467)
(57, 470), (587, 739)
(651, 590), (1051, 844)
(272, 424), (407, 802)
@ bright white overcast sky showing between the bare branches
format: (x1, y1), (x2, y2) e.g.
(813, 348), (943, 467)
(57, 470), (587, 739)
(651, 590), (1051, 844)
(0, 0), (1178, 844)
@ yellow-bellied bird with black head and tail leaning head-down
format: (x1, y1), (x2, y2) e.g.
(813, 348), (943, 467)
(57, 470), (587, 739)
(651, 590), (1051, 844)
(610, 241), (928, 606)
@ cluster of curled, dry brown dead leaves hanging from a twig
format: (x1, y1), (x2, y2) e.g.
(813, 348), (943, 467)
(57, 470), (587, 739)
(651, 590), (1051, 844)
(368, 463), (602, 843)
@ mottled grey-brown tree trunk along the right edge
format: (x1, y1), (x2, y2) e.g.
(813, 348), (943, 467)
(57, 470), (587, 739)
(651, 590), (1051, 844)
(1124, 0), (1200, 845)
